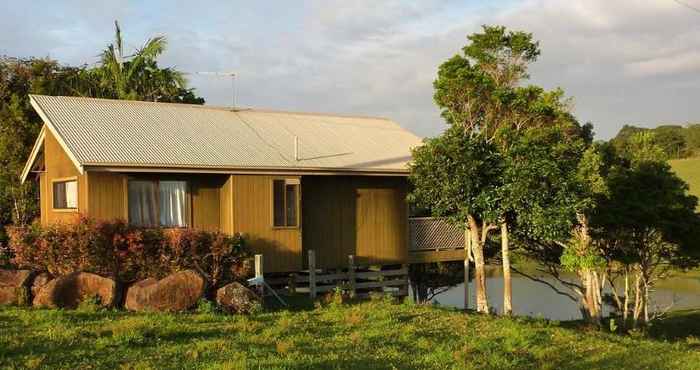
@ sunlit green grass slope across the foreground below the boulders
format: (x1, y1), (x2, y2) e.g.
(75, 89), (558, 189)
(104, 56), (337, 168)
(0, 300), (700, 369)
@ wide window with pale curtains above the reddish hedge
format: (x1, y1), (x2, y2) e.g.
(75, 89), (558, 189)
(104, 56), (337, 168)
(129, 180), (188, 227)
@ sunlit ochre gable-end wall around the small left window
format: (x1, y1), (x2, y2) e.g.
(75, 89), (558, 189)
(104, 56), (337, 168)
(39, 130), (88, 225)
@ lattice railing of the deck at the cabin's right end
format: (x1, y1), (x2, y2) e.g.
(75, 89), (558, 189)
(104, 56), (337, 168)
(408, 217), (464, 251)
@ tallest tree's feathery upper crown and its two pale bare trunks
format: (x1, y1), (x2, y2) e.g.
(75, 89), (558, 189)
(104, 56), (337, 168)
(426, 26), (558, 313)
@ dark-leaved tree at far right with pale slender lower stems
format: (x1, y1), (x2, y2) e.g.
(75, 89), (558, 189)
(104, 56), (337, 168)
(592, 132), (700, 326)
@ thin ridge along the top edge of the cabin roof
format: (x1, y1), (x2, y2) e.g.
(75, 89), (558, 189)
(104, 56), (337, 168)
(29, 94), (396, 123)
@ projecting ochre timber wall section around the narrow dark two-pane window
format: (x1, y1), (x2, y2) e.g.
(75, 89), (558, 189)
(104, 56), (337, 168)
(232, 175), (304, 272)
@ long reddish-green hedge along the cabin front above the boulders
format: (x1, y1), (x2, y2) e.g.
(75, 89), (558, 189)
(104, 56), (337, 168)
(8, 217), (251, 288)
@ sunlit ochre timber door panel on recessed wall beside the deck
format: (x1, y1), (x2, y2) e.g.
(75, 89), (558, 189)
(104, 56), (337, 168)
(355, 188), (408, 265)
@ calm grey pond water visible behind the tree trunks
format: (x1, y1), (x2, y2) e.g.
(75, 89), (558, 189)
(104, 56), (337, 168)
(433, 267), (700, 321)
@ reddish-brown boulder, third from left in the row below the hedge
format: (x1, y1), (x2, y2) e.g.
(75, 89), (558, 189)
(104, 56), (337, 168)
(124, 270), (206, 312)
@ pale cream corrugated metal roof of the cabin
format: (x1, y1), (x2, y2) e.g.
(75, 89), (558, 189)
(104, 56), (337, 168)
(31, 95), (421, 172)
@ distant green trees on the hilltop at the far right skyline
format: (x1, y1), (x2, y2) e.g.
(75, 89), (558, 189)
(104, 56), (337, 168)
(610, 124), (700, 159)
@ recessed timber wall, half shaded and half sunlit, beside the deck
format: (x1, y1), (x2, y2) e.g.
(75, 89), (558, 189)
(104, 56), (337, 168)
(302, 176), (408, 268)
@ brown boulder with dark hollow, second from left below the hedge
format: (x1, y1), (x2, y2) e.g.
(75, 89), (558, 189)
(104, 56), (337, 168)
(34, 272), (117, 308)
